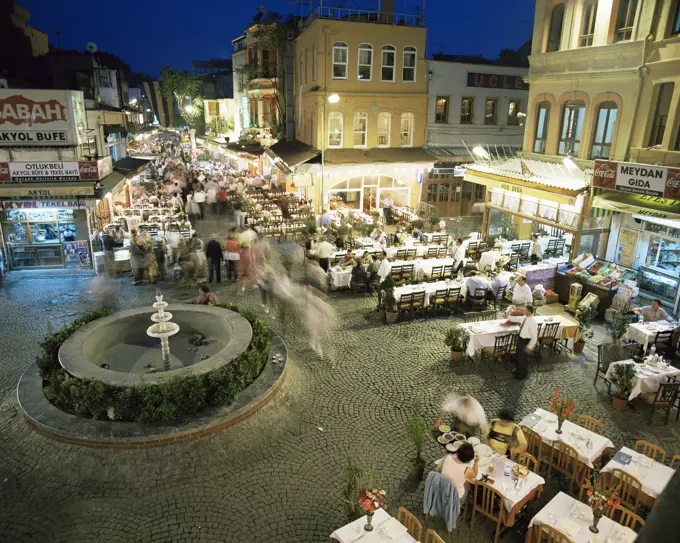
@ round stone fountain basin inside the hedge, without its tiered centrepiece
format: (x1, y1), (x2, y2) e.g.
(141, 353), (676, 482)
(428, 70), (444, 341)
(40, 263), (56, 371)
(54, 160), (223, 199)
(59, 304), (252, 387)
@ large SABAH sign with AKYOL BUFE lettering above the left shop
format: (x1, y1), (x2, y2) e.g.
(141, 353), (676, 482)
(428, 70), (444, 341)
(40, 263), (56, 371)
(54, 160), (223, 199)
(0, 89), (87, 147)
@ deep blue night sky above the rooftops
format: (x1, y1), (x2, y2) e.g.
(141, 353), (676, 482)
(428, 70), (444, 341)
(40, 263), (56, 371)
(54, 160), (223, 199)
(19, 0), (535, 76)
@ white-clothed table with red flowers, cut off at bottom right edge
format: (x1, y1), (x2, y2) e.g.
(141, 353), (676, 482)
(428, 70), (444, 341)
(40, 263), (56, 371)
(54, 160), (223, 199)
(526, 492), (637, 543)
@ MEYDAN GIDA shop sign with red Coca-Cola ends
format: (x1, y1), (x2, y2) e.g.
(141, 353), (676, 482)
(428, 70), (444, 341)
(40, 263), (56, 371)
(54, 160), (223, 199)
(593, 160), (680, 200)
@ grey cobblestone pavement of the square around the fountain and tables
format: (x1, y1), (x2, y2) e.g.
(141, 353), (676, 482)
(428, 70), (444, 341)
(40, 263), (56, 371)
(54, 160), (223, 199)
(0, 214), (680, 543)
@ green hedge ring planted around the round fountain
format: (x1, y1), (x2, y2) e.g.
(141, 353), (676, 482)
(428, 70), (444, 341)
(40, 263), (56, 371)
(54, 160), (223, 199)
(37, 303), (271, 424)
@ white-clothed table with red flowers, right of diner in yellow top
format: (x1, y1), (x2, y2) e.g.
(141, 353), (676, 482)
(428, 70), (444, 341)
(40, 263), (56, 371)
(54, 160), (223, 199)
(519, 407), (614, 469)
